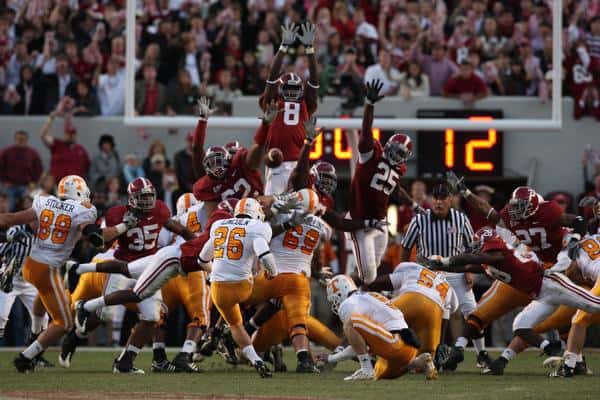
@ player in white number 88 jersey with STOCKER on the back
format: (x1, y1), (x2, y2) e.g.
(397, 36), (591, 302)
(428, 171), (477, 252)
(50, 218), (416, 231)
(0, 175), (135, 372)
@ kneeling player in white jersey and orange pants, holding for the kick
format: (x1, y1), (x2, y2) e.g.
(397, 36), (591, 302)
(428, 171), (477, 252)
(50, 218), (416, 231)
(318, 275), (437, 381)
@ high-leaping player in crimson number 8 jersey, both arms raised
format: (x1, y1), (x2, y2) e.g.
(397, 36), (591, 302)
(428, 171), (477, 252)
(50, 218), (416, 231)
(255, 21), (319, 194)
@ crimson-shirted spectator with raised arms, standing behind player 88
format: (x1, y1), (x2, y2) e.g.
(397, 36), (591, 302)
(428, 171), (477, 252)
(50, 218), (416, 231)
(40, 106), (90, 181)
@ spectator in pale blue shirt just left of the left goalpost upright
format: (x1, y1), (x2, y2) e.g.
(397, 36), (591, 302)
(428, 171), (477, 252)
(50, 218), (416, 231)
(96, 57), (125, 116)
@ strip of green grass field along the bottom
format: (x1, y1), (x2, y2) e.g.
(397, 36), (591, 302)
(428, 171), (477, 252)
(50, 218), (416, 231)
(0, 349), (600, 400)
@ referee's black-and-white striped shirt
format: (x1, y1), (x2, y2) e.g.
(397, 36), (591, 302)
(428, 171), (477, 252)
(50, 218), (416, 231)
(402, 208), (473, 257)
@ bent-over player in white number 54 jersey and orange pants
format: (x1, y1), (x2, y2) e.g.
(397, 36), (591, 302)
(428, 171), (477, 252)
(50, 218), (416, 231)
(369, 262), (458, 354)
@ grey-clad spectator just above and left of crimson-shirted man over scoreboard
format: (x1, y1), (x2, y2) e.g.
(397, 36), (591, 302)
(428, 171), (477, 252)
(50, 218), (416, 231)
(415, 43), (458, 96)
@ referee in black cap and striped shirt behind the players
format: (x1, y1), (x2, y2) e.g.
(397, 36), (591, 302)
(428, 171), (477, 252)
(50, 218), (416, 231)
(400, 184), (491, 369)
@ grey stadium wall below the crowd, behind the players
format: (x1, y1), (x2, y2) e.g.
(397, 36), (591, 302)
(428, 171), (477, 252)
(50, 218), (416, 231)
(0, 97), (600, 194)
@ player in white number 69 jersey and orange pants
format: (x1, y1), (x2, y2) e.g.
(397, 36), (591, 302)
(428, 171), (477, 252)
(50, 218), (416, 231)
(248, 211), (331, 373)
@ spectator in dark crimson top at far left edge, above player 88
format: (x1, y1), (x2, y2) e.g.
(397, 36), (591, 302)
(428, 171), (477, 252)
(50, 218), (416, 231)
(0, 131), (43, 211)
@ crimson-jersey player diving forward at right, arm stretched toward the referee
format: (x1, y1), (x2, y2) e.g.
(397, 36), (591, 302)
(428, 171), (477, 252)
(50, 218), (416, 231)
(427, 227), (600, 376)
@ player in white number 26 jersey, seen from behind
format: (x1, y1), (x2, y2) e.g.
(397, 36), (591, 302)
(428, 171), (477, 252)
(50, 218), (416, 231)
(198, 198), (277, 378)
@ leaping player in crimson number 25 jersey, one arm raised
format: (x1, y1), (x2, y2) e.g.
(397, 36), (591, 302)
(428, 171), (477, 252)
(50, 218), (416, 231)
(350, 80), (412, 284)
